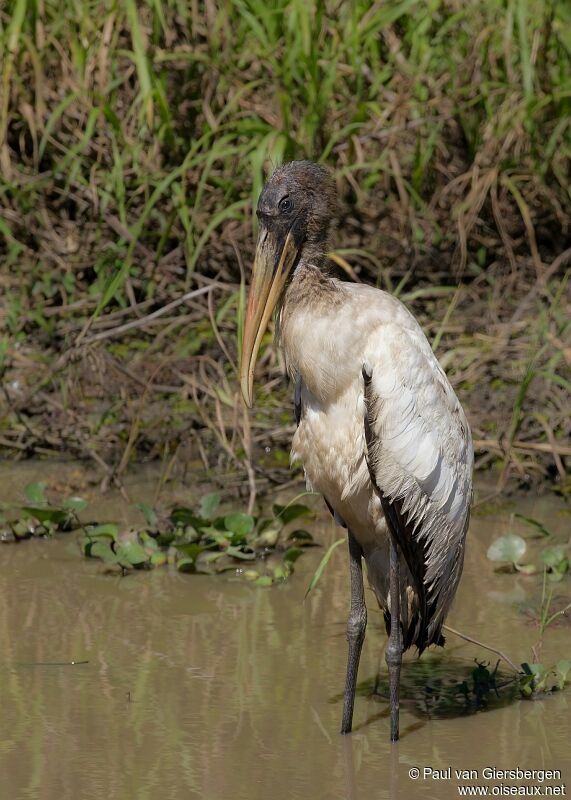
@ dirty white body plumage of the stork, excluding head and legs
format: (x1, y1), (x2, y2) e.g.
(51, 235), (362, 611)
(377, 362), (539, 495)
(279, 272), (473, 649)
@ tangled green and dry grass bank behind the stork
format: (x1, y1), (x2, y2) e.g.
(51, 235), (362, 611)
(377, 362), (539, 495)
(0, 0), (571, 500)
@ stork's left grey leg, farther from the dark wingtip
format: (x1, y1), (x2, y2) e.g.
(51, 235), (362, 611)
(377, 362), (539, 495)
(341, 531), (367, 733)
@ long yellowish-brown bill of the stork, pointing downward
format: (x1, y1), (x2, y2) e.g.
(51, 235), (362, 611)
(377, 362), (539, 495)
(240, 229), (297, 408)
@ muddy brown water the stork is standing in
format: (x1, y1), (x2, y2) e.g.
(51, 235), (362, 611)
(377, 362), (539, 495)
(0, 464), (571, 800)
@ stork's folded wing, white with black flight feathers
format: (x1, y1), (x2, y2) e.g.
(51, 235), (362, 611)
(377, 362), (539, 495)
(363, 318), (473, 650)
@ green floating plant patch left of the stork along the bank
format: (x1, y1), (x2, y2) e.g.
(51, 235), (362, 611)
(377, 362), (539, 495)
(0, 483), (315, 586)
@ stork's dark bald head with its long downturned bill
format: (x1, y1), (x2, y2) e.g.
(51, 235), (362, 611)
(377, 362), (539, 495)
(240, 161), (338, 408)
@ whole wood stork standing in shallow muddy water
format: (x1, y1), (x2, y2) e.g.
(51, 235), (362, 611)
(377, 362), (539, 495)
(240, 161), (474, 741)
